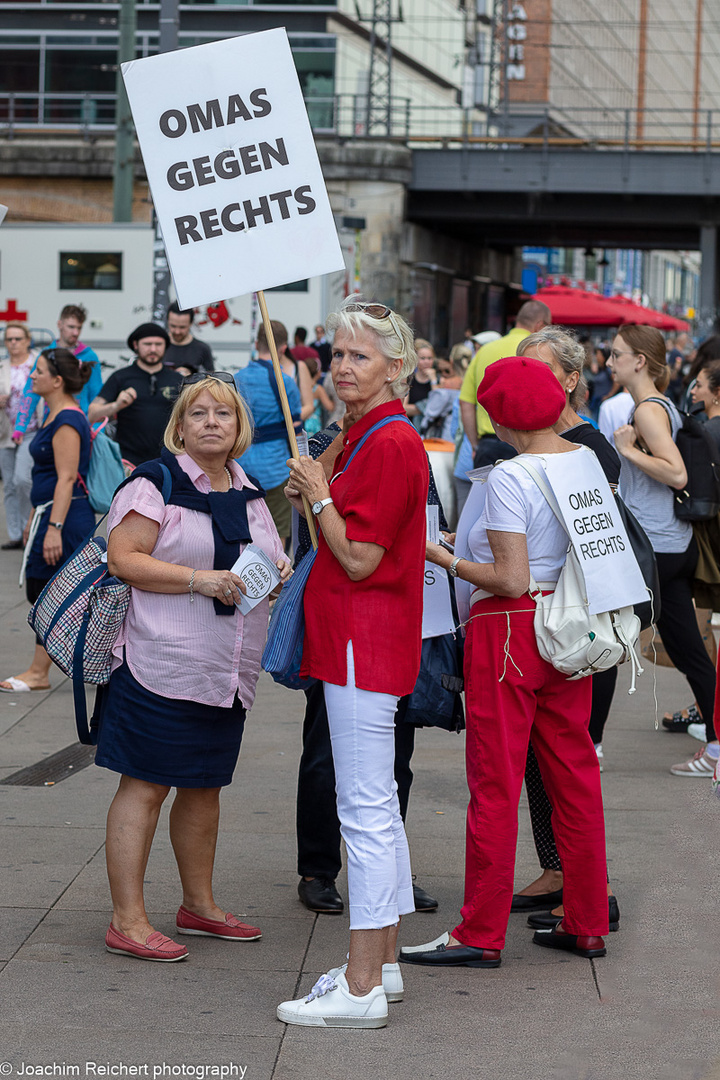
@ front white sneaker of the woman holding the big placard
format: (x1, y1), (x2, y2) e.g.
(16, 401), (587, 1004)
(277, 972), (388, 1027)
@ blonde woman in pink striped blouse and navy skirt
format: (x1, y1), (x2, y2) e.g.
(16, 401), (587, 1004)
(96, 372), (289, 961)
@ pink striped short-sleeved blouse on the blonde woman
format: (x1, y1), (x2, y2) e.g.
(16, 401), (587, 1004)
(108, 454), (285, 708)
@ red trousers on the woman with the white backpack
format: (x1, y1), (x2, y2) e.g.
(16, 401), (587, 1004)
(452, 595), (608, 949)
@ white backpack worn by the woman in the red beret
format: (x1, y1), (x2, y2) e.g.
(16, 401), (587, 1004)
(515, 457), (642, 693)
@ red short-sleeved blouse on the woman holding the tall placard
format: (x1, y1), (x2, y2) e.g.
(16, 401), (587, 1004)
(301, 401), (429, 697)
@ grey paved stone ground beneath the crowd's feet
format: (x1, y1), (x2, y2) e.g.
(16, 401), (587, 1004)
(0, 507), (720, 1080)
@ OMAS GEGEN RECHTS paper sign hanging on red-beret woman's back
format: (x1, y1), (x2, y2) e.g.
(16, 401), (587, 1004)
(543, 450), (648, 615)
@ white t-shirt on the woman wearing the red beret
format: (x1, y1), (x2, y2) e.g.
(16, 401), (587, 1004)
(467, 446), (587, 582)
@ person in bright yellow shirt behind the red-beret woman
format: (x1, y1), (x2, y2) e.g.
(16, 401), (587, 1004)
(460, 300), (553, 469)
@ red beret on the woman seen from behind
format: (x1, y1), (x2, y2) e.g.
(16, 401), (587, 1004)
(477, 356), (566, 431)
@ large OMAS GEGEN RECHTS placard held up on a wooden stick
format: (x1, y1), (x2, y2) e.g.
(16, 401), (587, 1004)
(122, 28), (344, 308)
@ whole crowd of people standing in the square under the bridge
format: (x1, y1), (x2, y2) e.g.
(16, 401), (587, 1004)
(0, 296), (720, 1028)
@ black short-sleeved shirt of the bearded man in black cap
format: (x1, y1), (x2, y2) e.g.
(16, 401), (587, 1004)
(99, 362), (182, 465)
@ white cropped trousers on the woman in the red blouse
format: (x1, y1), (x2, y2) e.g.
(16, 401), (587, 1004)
(324, 642), (415, 930)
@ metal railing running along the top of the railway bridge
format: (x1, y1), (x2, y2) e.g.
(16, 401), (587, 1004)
(0, 91), (720, 152)
